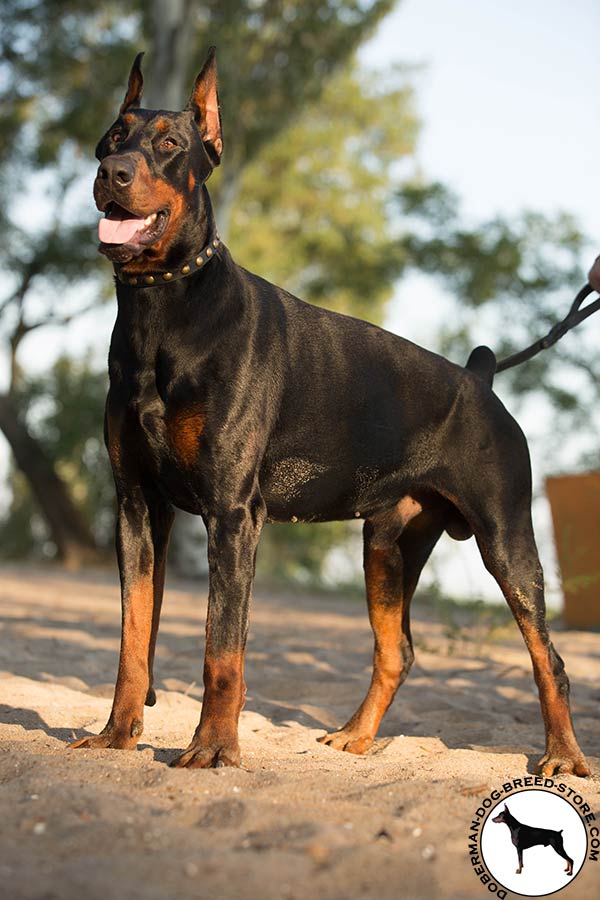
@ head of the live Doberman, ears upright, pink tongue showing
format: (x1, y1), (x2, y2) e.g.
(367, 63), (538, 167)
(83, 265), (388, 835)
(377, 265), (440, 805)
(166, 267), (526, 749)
(94, 47), (223, 271)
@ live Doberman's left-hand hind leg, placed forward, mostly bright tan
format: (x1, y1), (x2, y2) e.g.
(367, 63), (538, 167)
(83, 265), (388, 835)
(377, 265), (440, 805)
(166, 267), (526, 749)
(319, 504), (444, 753)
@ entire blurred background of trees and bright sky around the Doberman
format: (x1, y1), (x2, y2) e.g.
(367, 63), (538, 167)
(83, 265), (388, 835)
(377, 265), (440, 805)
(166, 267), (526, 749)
(0, 0), (600, 603)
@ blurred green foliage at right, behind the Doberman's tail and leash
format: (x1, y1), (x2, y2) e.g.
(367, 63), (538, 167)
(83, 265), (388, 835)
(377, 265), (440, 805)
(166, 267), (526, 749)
(398, 184), (600, 468)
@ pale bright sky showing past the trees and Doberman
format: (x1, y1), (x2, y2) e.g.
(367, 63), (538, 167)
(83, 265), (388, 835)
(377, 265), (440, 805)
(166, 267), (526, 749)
(4, 0), (600, 600)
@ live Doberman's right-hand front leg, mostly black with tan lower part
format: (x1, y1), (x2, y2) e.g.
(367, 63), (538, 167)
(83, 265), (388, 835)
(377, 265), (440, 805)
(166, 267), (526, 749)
(171, 499), (264, 769)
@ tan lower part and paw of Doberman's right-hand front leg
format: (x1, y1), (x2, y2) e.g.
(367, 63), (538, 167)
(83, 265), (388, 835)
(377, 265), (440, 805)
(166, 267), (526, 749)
(171, 647), (246, 769)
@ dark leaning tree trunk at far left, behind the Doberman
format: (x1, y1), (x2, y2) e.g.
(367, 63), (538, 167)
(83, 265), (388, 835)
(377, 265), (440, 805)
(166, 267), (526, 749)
(0, 395), (100, 568)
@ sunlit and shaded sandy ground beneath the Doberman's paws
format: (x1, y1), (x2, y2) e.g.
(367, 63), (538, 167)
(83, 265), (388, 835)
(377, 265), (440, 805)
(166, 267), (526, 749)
(0, 568), (600, 900)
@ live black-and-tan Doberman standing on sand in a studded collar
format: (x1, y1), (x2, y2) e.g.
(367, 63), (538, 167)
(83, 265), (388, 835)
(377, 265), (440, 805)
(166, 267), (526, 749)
(73, 48), (589, 775)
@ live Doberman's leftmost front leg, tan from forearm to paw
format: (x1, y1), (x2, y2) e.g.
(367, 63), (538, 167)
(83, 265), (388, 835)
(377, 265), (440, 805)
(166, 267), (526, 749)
(70, 485), (173, 750)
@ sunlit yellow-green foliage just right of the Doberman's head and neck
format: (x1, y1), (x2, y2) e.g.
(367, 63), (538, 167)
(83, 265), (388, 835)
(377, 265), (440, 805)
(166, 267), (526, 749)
(229, 65), (417, 321)
